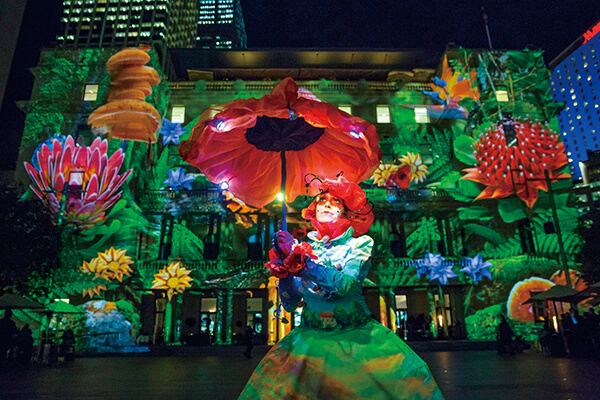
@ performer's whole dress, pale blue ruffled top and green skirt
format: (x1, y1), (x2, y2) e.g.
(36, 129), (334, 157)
(240, 228), (443, 400)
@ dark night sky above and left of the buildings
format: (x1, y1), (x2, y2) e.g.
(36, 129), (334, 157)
(0, 0), (600, 169)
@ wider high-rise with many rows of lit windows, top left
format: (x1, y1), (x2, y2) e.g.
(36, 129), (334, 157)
(57, 0), (198, 48)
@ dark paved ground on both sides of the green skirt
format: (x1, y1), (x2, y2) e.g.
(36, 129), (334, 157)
(0, 347), (600, 400)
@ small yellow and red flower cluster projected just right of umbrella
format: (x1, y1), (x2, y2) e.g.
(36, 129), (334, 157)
(371, 152), (428, 189)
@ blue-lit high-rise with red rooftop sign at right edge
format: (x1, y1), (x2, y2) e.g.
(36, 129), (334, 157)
(551, 22), (600, 183)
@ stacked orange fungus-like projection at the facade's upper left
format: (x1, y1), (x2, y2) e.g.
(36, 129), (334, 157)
(88, 46), (162, 143)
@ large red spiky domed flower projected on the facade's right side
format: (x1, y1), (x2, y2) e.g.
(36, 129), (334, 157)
(461, 119), (570, 208)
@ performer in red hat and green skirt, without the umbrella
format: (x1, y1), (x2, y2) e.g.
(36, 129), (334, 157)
(240, 176), (443, 400)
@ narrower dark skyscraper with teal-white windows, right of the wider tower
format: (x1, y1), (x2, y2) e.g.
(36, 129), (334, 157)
(196, 0), (246, 49)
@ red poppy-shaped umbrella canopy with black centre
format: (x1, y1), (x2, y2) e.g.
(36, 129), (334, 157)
(179, 78), (381, 207)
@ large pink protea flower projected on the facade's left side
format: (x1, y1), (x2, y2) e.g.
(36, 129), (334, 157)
(25, 136), (132, 230)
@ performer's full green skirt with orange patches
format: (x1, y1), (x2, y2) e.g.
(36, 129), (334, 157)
(240, 320), (443, 400)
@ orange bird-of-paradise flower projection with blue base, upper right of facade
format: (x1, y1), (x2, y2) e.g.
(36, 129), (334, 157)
(403, 57), (480, 119)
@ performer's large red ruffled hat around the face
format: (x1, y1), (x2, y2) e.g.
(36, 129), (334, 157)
(302, 176), (375, 237)
